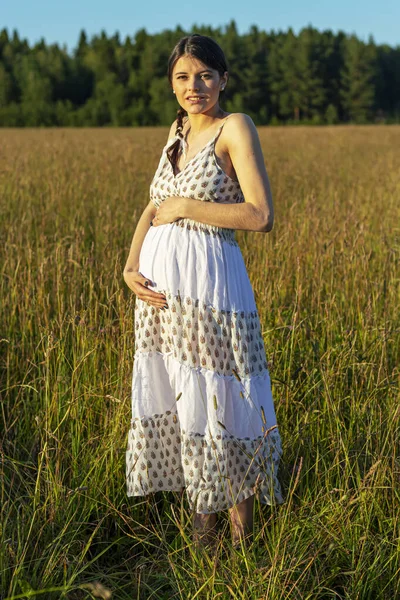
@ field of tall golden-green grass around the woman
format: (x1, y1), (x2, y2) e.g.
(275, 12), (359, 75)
(0, 126), (400, 600)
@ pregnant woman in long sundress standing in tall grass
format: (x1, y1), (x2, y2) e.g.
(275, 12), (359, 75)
(124, 34), (283, 544)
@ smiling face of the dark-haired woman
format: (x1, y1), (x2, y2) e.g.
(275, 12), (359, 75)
(172, 54), (228, 115)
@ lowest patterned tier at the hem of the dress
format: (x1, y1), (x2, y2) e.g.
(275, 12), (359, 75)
(126, 411), (283, 514)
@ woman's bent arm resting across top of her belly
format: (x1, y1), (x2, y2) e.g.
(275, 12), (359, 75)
(155, 113), (274, 233)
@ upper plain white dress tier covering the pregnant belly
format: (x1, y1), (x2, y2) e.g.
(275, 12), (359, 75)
(139, 223), (256, 311)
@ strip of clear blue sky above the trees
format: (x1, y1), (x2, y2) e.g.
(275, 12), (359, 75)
(0, 0), (400, 51)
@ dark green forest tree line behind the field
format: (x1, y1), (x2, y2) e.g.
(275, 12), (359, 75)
(0, 21), (400, 127)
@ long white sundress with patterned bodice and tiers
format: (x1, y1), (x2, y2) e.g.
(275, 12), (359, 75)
(126, 117), (283, 514)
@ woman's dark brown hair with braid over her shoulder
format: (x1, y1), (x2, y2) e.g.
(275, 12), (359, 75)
(167, 33), (228, 170)
